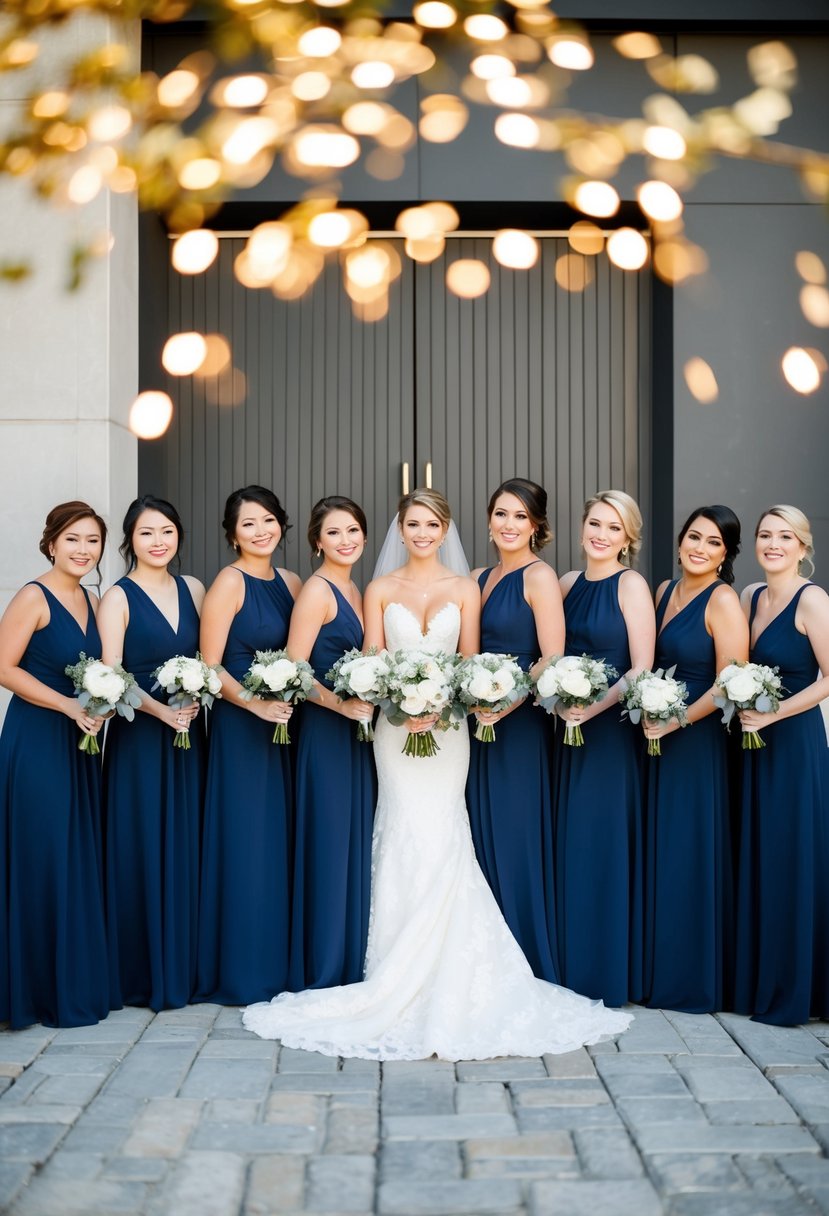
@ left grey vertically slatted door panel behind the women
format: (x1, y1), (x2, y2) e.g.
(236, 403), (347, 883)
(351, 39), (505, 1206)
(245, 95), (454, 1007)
(140, 237), (415, 580)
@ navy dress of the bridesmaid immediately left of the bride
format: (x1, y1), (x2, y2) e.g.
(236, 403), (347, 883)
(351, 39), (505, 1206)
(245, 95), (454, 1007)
(288, 579), (377, 992)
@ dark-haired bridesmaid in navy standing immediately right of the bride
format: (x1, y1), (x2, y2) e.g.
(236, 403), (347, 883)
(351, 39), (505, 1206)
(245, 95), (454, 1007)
(467, 477), (564, 984)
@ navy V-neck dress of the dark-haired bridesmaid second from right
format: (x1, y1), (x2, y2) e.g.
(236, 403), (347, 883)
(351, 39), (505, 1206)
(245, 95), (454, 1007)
(644, 581), (733, 1013)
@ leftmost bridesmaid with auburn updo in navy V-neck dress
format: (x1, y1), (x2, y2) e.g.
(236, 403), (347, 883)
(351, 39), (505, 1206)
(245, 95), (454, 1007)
(0, 502), (109, 1030)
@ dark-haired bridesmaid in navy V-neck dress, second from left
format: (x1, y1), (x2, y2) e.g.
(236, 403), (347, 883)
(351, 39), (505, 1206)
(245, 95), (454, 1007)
(98, 495), (205, 1010)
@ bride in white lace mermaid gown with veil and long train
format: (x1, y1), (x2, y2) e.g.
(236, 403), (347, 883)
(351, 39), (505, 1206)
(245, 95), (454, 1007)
(243, 490), (631, 1060)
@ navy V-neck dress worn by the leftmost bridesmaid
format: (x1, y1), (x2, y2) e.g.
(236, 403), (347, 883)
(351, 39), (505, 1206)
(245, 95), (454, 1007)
(0, 582), (109, 1030)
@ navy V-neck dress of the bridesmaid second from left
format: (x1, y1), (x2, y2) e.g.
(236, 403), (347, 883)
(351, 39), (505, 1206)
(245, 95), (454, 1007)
(103, 578), (207, 1010)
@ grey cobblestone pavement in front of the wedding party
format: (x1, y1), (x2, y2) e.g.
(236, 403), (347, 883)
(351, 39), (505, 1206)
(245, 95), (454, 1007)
(0, 1006), (829, 1216)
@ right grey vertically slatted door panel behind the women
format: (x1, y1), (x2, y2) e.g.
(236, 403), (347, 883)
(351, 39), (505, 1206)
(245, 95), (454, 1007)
(415, 236), (650, 570)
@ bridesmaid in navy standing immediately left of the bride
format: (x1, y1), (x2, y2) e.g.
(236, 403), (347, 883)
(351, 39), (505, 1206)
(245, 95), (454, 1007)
(288, 496), (377, 991)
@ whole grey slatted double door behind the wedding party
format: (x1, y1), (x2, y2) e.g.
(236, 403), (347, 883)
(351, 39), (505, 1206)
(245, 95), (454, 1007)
(139, 236), (650, 581)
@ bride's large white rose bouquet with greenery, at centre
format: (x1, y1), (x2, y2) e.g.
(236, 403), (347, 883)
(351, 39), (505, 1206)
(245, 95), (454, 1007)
(380, 651), (466, 756)
